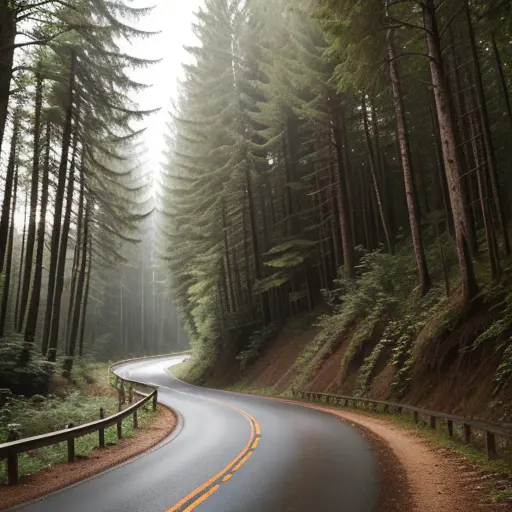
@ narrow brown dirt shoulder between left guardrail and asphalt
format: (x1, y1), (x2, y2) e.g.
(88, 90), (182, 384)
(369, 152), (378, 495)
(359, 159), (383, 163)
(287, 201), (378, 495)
(0, 405), (177, 510)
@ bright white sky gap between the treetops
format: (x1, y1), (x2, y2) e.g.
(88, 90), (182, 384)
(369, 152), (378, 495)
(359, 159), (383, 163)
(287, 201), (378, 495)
(121, 0), (203, 175)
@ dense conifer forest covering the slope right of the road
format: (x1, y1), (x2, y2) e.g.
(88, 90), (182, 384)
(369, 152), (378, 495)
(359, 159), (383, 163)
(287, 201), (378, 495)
(167, 0), (512, 398)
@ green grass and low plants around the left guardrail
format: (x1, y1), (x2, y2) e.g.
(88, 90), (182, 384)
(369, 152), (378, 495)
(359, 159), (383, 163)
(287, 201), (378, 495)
(0, 364), (155, 485)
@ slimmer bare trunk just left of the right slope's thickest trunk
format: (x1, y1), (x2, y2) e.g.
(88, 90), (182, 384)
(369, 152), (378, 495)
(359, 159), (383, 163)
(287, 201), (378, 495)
(387, 31), (431, 296)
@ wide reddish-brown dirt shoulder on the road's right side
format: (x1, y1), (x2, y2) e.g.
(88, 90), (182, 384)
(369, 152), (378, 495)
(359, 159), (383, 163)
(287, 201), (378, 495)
(270, 400), (512, 512)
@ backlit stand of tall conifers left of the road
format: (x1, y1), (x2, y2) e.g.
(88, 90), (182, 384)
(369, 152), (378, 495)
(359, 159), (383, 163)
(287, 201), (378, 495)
(0, 0), (187, 394)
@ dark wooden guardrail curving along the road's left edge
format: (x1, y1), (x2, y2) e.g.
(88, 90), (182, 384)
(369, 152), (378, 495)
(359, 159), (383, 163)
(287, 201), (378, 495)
(0, 363), (158, 485)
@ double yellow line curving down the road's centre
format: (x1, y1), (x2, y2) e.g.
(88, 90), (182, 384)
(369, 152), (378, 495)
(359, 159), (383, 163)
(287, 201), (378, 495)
(167, 400), (261, 512)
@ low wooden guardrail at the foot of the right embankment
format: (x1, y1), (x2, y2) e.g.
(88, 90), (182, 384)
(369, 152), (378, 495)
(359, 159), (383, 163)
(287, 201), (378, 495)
(298, 391), (512, 460)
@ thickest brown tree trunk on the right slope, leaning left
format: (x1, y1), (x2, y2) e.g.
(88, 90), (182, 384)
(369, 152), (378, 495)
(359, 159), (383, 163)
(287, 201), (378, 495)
(423, 0), (478, 305)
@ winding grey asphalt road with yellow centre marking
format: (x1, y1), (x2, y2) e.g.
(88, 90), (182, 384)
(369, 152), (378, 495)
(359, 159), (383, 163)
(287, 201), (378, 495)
(16, 356), (379, 512)
